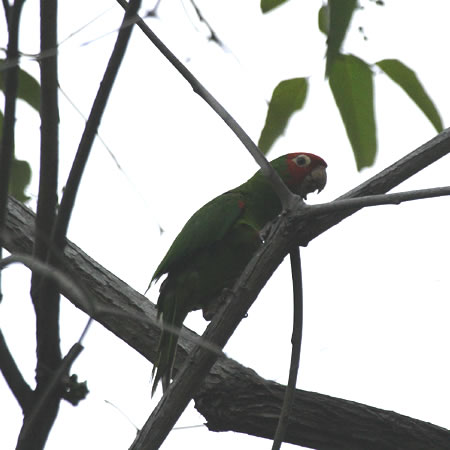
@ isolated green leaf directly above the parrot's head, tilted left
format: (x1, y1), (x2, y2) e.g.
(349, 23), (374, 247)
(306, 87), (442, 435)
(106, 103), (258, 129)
(258, 78), (308, 154)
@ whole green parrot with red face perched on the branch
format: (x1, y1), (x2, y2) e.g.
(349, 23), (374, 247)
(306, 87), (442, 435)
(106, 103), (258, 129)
(149, 153), (327, 395)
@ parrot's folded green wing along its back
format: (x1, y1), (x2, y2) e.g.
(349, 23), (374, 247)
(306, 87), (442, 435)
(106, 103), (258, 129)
(151, 191), (245, 282)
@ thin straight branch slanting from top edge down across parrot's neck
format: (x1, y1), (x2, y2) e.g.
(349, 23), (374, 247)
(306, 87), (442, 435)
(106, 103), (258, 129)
(117, 0), (293, 209)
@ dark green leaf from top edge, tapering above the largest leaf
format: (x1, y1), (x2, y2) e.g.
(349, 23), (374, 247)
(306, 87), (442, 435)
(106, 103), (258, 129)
(325, 0), (357, 77)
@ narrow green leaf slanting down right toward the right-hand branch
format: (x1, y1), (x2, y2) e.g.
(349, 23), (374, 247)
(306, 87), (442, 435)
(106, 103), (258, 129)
(376, 59), (444, 133)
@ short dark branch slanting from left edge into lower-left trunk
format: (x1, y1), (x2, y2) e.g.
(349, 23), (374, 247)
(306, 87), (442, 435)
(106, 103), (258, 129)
(0, 330), (33, 414)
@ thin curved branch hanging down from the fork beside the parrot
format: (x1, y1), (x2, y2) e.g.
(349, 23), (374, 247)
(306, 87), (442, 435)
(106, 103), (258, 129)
(272, 247), (303, 450)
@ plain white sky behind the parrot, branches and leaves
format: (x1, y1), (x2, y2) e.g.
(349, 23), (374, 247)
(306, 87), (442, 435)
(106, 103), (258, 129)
(0, 0), (450, 450)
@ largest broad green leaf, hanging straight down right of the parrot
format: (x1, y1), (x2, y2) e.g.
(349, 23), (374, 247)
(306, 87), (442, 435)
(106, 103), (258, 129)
(329, 55), (377, 170)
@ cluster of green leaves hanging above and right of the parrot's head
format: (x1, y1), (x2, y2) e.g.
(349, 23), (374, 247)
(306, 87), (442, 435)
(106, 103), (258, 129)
(258, 0), (443, 170)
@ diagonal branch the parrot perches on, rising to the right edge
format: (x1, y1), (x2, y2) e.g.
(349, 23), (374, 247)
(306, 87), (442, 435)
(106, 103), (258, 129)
(132, 130), (450, 449)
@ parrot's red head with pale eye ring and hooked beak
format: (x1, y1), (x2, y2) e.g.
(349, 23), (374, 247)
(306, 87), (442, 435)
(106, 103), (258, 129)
(275, 153), (327, 199)
